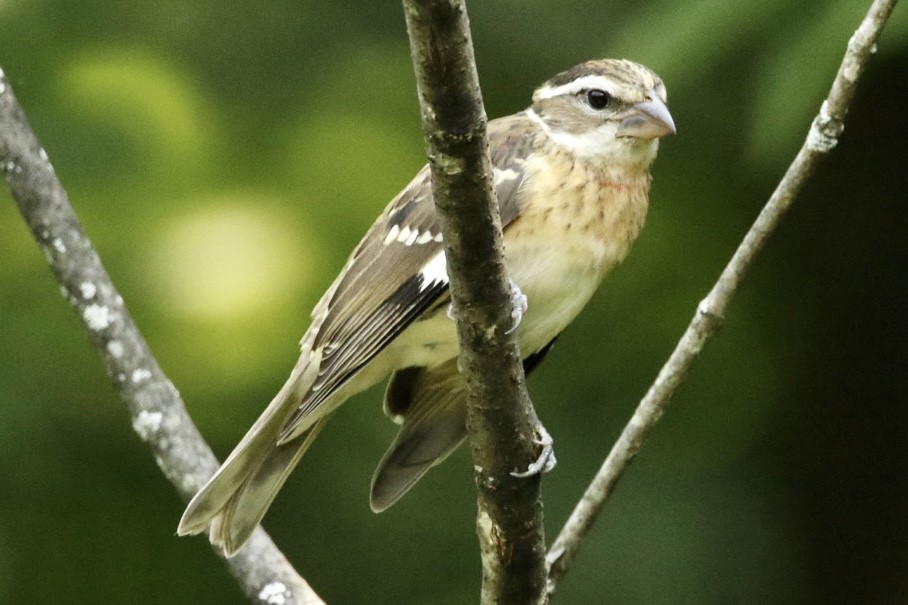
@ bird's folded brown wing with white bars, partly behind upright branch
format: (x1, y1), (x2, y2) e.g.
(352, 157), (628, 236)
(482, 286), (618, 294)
(282, 113), (532, 437)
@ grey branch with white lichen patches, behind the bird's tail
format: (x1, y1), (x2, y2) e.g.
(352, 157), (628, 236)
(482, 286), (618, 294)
(0, 65), (322, 605)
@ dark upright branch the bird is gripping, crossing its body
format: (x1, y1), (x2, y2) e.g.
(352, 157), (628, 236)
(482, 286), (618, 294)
(403, 0), (547, 605)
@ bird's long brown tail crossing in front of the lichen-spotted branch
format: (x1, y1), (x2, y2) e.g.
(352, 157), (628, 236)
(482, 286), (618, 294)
(177, 356), (327, 557)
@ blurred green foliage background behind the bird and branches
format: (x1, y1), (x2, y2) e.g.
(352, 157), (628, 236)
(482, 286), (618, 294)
(0, 0), (908, 605)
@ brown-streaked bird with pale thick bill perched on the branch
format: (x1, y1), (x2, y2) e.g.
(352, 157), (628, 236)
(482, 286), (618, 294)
(177, 59), (675, 556)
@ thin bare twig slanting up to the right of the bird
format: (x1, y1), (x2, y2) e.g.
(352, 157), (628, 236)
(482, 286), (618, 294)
(546, 0), (897, 593)
